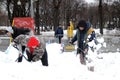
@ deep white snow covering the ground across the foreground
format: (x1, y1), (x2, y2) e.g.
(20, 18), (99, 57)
(0, 28), (120, 80)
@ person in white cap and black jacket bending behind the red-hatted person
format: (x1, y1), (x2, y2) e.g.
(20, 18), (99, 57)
(6, 26), (31, 62)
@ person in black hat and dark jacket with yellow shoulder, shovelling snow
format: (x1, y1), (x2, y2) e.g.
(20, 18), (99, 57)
(70, 20), (95, 64)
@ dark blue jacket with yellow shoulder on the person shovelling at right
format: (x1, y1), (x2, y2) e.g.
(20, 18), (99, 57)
(71, 26), (95, 50)
